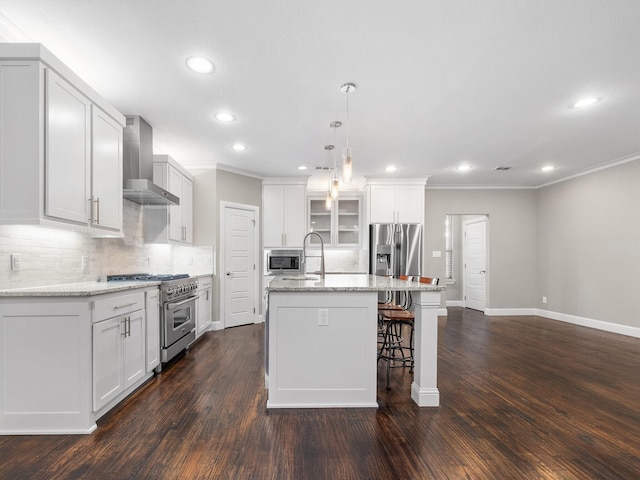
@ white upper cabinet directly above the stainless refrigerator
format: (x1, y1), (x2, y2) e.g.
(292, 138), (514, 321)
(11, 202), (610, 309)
(366, 178), (426, 223)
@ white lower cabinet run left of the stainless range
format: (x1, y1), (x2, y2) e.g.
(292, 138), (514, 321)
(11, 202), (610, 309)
(0, 286), (160, 435)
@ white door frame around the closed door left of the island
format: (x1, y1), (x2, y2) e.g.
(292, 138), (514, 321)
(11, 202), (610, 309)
(218, 201), (262, 329)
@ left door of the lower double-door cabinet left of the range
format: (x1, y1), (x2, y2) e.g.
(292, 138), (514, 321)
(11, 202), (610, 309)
(93, 317), (124, 412)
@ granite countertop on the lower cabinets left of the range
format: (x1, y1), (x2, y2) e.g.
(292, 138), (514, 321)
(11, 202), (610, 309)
(0, 281), (160, 297)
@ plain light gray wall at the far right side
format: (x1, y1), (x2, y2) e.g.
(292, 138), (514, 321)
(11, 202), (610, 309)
(535, 160), (640, 328)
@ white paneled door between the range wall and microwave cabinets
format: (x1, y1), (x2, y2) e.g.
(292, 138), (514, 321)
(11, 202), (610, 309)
(222, 206), (256, 327)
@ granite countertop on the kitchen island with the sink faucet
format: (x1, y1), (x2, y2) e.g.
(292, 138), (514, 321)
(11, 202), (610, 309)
(267, 274), (446, 292)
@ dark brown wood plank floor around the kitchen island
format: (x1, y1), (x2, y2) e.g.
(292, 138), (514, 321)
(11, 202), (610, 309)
(0, 308), (640, 480)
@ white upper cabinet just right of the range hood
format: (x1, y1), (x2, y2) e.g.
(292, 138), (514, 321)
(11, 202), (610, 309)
(144, 155), (193, 245)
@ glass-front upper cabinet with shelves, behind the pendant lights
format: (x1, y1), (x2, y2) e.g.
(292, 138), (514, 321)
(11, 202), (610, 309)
(307, 195), (362, 247)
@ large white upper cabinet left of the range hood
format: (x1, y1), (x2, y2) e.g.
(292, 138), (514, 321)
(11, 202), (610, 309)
(0, 44), (125, 236)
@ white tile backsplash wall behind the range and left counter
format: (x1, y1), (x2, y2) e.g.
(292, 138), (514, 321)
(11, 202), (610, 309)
(0, 200), (212, 289)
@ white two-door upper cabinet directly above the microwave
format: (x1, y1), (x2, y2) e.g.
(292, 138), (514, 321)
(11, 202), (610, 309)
(262, 179), (306, 248)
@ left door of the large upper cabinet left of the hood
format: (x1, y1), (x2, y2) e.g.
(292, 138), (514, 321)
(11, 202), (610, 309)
(45, 70), (91, 223)
